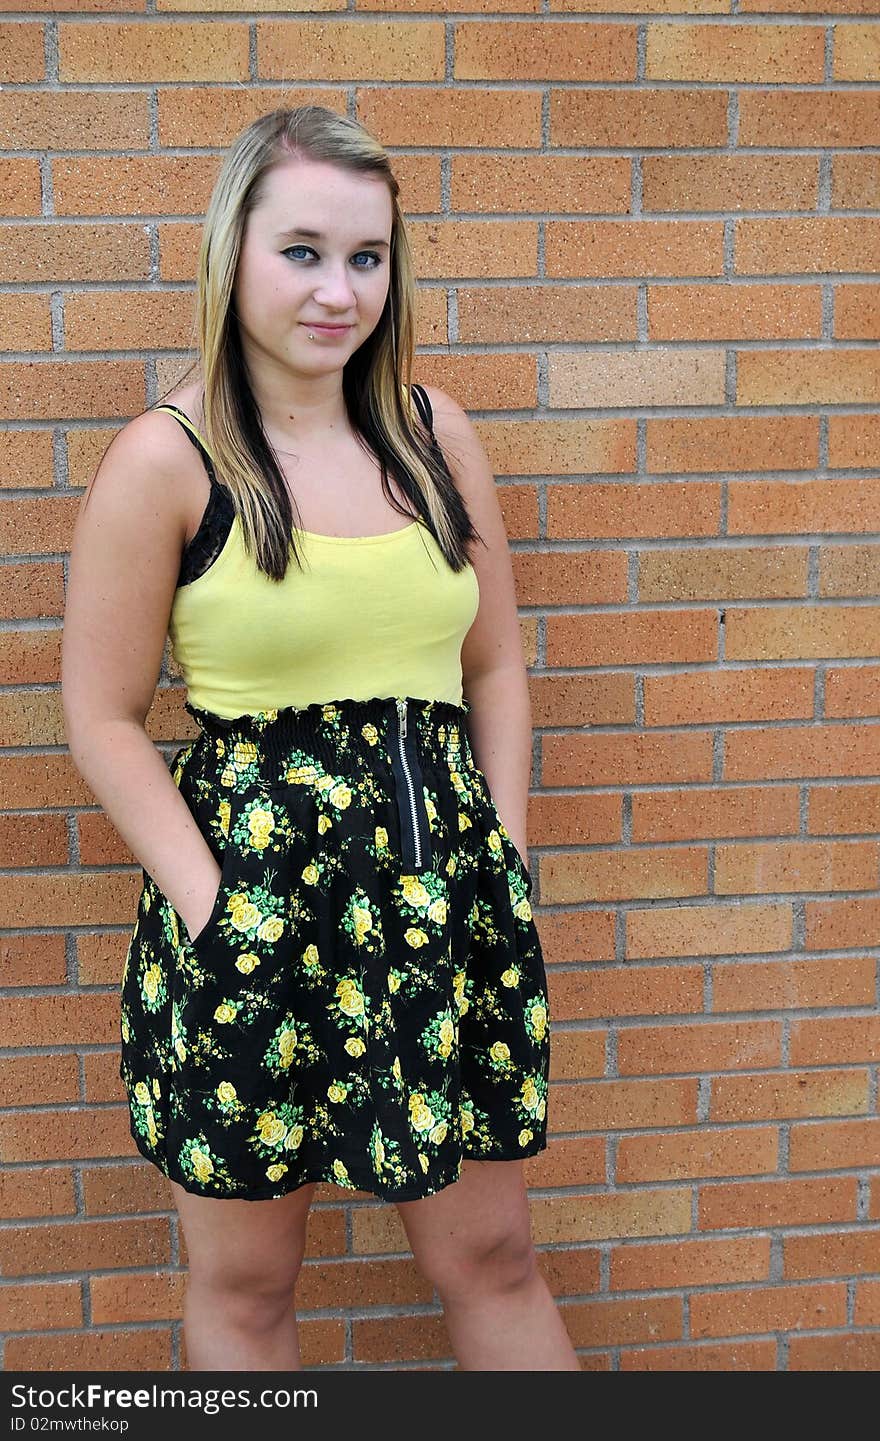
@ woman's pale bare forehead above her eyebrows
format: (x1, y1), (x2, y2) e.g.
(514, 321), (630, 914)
(252, 160), (392, 239)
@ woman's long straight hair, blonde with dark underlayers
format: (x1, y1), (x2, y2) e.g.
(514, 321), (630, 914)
(156, 105), (481, 581)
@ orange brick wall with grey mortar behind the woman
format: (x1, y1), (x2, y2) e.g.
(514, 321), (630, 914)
(0, 0), (880, 1370)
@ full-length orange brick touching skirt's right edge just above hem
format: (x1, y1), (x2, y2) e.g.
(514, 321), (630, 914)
(547, 1081), (697, 1131)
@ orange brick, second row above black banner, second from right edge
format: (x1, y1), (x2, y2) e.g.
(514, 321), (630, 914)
(690, 1285), (847, 1340)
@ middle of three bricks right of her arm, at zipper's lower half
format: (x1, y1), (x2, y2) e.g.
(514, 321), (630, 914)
(632, 783), (799, 843)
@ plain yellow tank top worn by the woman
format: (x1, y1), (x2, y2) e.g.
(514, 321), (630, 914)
(165, 406), (480, 719)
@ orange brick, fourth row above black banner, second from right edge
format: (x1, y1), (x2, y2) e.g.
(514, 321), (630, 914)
(699, 1176), (858, 1231)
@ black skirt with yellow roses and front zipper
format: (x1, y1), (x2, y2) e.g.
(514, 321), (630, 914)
(120, 696), (549, 1200)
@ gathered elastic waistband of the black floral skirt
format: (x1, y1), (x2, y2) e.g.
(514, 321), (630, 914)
(184, 696), (472, 780)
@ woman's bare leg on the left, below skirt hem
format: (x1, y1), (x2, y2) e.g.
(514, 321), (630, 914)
(171, 1182), (314, 1370)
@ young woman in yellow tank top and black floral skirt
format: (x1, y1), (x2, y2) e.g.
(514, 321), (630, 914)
(62, 105), (578, 1370)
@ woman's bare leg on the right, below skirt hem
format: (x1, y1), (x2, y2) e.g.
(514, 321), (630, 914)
(398, 1161), (580, 1370)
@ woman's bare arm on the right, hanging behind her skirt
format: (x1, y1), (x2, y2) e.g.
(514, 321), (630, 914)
(425, 386), (533, 863)
